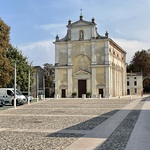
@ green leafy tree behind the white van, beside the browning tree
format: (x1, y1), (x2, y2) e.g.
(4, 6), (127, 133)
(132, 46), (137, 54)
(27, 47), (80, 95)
(7, 46), (33, 91)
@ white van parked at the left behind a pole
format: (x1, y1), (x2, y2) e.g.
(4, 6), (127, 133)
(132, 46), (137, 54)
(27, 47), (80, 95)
(0, 88), (27, 105)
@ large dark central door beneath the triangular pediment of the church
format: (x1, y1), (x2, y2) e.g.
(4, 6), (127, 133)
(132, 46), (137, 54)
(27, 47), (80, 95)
(78, 80), (86, 97)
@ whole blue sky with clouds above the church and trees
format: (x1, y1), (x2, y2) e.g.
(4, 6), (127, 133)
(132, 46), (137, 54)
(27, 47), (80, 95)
(0, 0), (150, 67)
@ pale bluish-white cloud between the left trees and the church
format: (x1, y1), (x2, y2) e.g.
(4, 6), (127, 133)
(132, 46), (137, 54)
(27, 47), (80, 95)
(19, 40), (55, 66)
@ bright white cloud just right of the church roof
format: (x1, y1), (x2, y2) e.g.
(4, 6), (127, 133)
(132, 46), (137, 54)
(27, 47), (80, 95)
(113, 38), (150, 63)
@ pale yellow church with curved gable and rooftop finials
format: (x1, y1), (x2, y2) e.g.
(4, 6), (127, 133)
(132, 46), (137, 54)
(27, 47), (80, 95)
(54, 14), (126, 98)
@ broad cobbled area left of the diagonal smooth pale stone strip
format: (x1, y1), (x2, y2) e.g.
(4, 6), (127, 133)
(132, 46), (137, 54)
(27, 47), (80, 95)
(0, 98), (144, 150)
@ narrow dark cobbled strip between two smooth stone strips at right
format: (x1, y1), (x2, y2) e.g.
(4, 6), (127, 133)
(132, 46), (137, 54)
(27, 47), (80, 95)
(97, 101), (144, 150)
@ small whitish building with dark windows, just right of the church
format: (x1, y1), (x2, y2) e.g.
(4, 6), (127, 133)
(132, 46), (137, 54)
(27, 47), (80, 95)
(127, 72), (143, 95)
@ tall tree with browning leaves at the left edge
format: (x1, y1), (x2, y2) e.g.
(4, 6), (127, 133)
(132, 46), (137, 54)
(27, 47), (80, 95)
(0, 18), (12, 87)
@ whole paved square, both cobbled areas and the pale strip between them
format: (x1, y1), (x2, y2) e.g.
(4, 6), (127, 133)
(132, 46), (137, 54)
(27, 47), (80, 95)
(0, 97), (148, 150)
